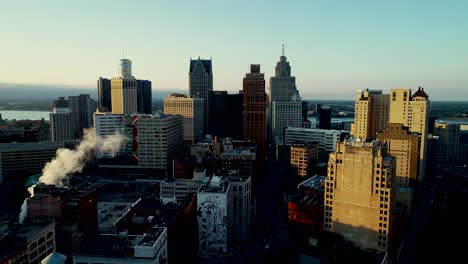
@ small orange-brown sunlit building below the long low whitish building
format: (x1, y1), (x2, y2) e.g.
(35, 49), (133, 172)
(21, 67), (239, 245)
(290, 142), (319, 177)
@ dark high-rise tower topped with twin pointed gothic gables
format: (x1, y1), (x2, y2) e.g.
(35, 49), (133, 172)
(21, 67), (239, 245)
(189, 57), (213, 131)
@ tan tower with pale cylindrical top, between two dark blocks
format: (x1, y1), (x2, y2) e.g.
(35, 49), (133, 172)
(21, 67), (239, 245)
(111, 59), (138, 114)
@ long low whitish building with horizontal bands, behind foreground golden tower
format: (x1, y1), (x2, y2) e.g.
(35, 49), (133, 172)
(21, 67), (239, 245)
(284, 127), (349, 152)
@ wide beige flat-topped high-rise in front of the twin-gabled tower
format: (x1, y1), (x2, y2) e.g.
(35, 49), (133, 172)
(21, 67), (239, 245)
(164, 93), (205, 144)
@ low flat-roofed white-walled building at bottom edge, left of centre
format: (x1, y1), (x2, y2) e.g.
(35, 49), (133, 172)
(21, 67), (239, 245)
(73, 227), (169, 264)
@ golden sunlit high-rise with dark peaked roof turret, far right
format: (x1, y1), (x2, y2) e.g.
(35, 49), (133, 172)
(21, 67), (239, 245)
(389, 87), (430, 180)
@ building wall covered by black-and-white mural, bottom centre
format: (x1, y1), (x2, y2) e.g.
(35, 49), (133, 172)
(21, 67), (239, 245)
(197, 177), (233, 256)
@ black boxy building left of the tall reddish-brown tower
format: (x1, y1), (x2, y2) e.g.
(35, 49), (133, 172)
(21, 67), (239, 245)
(207, 91), (243, 138)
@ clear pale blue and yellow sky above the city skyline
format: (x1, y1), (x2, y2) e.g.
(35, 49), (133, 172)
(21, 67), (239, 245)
(0, 0), (468, 101)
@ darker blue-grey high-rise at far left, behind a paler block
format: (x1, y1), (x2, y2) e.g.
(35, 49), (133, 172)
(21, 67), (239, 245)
(68, 94), (97, 138)
